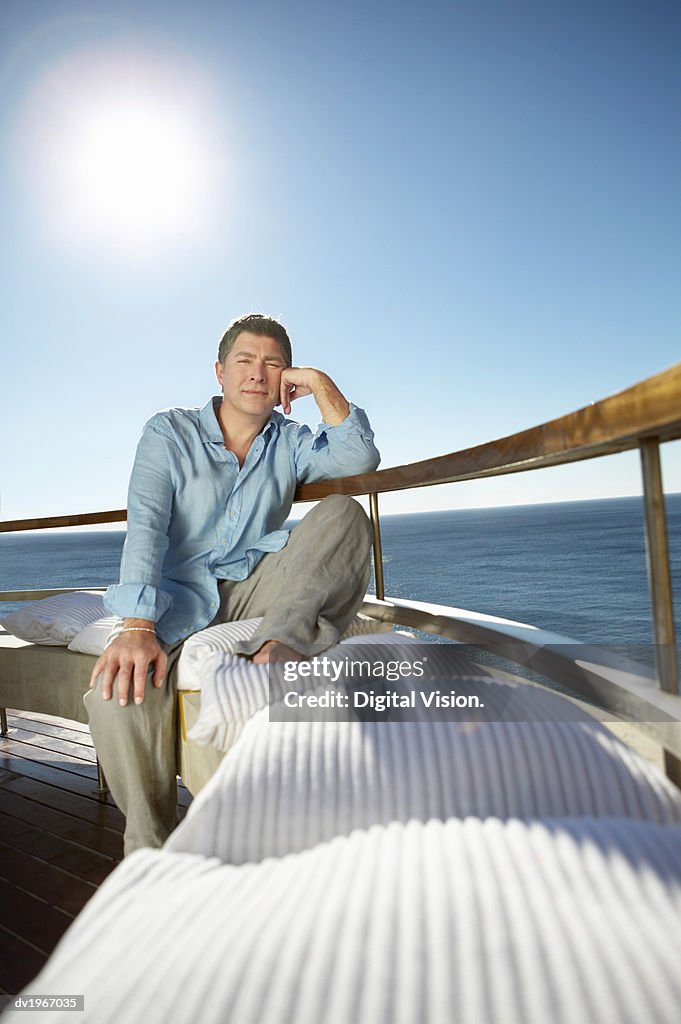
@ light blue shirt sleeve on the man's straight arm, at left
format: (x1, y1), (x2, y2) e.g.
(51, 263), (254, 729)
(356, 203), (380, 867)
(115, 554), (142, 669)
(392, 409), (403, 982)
(104, 417), (175, 622)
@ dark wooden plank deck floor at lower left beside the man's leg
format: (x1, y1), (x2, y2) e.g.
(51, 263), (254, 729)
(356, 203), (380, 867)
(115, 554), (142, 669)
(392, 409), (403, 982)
(0, 712), (191, 995)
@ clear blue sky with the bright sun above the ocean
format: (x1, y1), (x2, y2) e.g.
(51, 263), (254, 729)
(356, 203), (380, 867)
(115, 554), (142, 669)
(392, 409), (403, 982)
(0, 0), (681, 518)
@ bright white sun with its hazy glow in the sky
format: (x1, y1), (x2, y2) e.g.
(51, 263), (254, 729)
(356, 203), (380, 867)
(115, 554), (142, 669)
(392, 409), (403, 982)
(13, 53), (222, 256)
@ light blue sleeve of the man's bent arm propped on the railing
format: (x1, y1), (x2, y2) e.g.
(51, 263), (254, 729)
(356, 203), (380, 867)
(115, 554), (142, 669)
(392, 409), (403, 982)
(296, 403), (381, 483)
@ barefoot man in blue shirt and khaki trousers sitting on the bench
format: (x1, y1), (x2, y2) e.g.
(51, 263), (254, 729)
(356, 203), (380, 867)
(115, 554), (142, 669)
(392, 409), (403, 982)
(85, 314), (379, 854)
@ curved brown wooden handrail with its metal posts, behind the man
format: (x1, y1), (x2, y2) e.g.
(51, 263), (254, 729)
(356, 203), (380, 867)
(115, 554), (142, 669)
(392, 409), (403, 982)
(0, 364), (681, 778)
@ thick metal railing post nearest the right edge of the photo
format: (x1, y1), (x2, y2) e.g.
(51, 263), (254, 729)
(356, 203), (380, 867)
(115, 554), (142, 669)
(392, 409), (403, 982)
(640, 437), (681, 786)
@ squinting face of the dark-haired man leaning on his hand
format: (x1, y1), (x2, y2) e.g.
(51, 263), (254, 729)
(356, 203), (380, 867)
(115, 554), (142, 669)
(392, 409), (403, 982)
(215, 331), (286, 422)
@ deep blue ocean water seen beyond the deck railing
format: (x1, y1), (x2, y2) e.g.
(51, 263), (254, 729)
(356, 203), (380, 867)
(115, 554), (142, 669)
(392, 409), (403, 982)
(0, 495), (681, 645)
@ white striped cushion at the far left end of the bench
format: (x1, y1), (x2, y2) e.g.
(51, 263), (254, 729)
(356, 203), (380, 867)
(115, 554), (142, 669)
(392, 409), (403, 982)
(0, 591), (104, 647)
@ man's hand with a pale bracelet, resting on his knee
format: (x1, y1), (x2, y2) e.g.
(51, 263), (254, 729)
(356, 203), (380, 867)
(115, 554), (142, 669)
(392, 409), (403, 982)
(90, 623), (168, 705)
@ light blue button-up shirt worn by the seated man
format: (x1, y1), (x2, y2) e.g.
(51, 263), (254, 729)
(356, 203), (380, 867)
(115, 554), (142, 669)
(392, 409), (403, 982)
(104, 395), (380, 643)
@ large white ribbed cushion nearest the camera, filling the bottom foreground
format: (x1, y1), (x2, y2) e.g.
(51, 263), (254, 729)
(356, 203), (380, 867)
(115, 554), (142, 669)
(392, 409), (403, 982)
(13, 818), (681, 1024)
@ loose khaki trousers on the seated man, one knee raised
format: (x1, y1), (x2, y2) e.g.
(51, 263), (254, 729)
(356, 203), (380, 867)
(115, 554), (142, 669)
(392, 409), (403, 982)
(84, 495), (371, 855)
